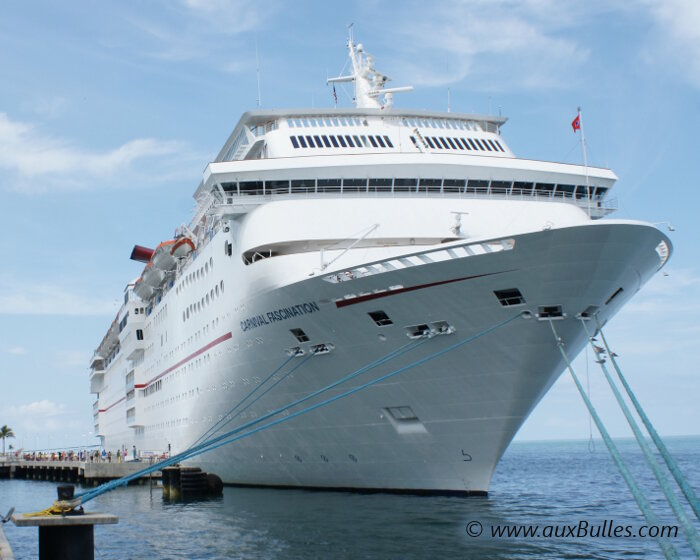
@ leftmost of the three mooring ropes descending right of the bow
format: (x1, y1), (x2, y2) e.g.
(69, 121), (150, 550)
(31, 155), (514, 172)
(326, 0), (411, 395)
(549, 319), (679, 560)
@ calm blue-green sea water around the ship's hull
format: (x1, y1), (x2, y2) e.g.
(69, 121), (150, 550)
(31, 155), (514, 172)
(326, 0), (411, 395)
(0, 437), (700, 559)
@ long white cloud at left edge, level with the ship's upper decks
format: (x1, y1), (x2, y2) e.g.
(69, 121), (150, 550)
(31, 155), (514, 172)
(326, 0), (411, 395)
(0, 113), (197, 192)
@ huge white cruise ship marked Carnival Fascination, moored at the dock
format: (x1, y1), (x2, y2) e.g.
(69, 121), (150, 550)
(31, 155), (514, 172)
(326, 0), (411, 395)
(90, 38), (672, 494)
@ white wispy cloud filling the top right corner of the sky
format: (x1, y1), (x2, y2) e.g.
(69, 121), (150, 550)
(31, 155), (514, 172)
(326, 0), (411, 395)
(642, 0), (700, 88)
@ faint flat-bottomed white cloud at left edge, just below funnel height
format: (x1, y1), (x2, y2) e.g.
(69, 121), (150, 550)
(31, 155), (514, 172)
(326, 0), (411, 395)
(0, 276), (116, 315)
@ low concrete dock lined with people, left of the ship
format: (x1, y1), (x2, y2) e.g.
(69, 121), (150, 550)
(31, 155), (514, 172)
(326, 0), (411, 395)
(0, 461), (161, 485)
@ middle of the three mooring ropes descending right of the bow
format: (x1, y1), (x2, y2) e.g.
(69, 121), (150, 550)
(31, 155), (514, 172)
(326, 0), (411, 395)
(581, 318), (700, 558)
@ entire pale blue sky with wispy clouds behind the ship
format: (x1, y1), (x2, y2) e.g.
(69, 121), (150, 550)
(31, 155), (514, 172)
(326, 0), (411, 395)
(0, 0), (700, 449)
